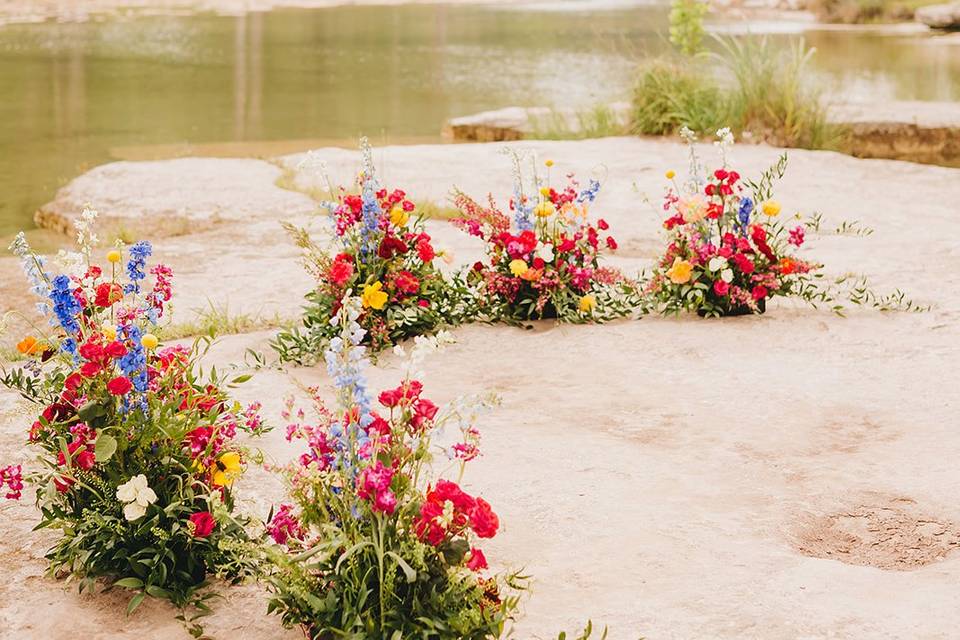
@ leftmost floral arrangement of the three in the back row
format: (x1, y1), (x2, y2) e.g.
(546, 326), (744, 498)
(274, 138), (462, 364)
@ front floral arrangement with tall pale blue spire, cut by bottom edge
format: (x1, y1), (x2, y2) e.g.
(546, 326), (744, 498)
(267, 297), (518, 640)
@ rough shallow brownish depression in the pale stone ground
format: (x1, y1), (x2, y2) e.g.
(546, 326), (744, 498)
(794, 498), (960, 571)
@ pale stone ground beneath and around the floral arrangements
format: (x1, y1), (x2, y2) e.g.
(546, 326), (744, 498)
(0, 138), (960, 640)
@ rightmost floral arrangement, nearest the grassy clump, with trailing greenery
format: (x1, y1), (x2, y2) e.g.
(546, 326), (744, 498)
(647, 130), (829, 316)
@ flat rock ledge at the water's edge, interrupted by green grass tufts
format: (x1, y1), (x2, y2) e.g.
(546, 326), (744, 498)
(443, 101), (960, 166)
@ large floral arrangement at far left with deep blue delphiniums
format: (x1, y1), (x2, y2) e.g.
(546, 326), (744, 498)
(0, 225), (264, 613)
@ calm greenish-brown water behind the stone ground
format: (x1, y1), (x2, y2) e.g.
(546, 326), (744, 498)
(0, 0), (960, 239)
